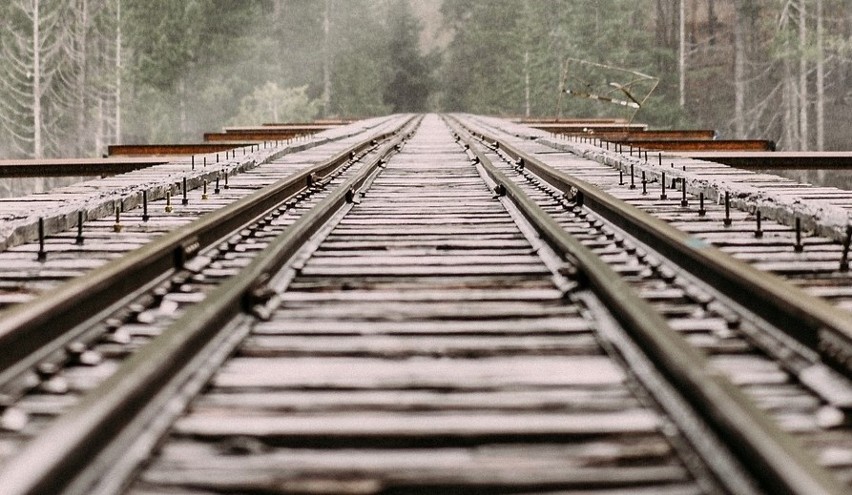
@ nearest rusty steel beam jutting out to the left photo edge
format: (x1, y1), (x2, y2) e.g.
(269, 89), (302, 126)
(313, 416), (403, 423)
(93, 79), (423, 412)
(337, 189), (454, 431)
(0, 158), (168, 177)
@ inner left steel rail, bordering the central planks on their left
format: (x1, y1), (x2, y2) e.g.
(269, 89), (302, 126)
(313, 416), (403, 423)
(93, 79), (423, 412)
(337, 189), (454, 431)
(0, 120), (411, 495)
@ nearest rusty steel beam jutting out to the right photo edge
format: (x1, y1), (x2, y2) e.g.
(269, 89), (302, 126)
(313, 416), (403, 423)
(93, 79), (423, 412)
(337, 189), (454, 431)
(672, 151), (852, 170)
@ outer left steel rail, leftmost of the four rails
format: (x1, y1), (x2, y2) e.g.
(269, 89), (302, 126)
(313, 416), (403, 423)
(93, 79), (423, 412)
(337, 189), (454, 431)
(0, 123), (406, 392)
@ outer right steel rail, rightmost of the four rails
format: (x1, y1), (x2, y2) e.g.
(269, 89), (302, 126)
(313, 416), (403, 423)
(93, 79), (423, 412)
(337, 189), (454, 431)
(460, 118), (852, 378)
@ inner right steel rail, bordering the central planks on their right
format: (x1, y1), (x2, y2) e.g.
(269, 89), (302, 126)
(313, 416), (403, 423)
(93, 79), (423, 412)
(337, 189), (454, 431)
(442, 117), (848, 495)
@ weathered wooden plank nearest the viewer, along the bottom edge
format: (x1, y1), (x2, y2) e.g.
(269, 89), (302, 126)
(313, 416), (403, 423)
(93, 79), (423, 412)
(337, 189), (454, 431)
(136, 444), (689, 494)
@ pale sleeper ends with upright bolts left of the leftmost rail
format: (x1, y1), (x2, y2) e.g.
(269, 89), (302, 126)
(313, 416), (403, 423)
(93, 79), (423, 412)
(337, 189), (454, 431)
(0, 116), (410, 310)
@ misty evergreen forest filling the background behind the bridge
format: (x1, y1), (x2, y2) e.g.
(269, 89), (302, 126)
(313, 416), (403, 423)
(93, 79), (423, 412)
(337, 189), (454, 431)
(0, 0), (852, 163)
